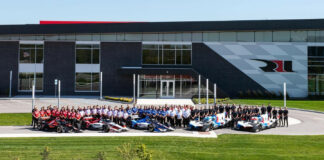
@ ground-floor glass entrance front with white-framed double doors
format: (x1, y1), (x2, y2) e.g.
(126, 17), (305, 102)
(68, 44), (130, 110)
(139, 75), (198, 98)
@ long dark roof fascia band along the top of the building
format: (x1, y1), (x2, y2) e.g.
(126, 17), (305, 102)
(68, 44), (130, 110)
(0, 19), (324, 35)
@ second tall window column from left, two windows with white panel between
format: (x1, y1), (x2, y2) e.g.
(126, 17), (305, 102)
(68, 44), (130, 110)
(75, 44), (100, 92)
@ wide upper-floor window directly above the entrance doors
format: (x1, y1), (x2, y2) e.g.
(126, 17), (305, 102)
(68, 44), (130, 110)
(142, 44), (191, 65)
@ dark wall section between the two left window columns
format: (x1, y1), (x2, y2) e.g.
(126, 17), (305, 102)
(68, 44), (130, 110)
(44, 42), (75, 95)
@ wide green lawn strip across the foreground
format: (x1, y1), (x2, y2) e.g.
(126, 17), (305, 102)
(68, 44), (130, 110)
(0, 135), (324, 160)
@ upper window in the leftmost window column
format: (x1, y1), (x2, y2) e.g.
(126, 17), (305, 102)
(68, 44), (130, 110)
(19, 44), (44, 63)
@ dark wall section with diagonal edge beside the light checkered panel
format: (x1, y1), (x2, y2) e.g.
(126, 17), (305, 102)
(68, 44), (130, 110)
(192, 43), (266, 97)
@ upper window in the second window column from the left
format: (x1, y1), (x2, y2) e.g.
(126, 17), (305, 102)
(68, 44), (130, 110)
(76, 44), (100, 64)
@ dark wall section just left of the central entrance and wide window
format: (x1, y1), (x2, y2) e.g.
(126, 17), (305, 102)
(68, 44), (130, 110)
(100, 42), (142, 96)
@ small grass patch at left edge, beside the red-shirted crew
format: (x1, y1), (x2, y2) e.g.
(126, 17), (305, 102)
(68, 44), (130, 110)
(0, 113), (32, 126)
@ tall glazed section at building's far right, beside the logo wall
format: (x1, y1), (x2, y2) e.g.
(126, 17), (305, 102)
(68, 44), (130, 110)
(308, 47), (324, 95)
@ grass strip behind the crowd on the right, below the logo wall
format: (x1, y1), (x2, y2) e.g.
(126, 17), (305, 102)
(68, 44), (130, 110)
(193, 98), (324, 111)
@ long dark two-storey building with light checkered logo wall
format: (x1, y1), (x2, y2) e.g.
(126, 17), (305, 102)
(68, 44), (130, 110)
(0, 19), (324, 98)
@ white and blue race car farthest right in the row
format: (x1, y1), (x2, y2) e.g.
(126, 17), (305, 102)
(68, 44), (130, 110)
(234, 114), (278, 132)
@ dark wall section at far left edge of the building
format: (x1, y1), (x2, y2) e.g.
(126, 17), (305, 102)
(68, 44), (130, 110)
(0, 41), (19, 96)
